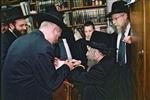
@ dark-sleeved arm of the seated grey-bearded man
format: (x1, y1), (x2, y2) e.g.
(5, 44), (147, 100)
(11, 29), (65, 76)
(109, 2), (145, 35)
(69, 58), (112, 85)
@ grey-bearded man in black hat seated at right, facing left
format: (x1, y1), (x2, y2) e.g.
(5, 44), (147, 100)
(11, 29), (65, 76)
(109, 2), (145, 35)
(69, 41), (114, 100)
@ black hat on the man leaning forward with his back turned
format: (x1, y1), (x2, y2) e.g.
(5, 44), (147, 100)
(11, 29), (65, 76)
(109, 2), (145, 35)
(36, 11), (65, 29)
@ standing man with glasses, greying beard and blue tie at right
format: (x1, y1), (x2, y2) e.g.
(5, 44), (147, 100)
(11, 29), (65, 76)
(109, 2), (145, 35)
(109, 1), (135, 100)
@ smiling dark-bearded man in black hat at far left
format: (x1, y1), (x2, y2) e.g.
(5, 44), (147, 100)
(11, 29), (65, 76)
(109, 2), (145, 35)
(1, 6), (29, 65)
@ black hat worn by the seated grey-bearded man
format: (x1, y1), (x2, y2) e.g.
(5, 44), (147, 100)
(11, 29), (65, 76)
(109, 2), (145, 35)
(86, 41), (111, 55)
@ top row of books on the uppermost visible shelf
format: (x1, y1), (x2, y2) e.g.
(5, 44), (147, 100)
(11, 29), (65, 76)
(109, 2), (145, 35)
(30, 0), (106, 11)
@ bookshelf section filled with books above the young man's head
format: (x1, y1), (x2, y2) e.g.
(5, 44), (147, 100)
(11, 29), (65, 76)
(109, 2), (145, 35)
(57, 0), (107, 31)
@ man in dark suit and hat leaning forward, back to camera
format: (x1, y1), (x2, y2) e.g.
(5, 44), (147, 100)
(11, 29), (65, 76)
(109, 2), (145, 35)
(2, 7), (78, 100)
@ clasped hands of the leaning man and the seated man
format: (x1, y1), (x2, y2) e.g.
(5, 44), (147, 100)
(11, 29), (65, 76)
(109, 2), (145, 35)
(54, 58), (84, 70)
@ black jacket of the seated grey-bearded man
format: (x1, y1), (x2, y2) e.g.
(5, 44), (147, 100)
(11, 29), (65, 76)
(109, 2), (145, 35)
(69, 57), (114, 100)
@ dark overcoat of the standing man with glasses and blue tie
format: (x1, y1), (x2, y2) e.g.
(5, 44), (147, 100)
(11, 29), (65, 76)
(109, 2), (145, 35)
(109, 31), (133, 100)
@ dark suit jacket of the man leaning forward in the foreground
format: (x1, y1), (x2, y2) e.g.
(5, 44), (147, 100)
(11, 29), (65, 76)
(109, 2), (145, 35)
(2, 31), (69, 100)
